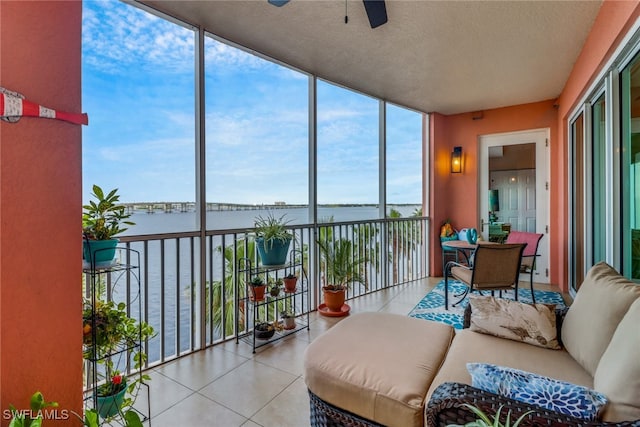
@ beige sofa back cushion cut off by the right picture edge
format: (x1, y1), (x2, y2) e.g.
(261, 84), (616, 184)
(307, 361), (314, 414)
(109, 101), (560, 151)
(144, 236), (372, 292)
(593, 299), (640, 421)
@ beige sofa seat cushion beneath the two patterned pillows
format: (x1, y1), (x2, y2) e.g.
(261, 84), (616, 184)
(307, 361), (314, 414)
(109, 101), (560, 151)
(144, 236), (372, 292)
(427, 329), (593, 401)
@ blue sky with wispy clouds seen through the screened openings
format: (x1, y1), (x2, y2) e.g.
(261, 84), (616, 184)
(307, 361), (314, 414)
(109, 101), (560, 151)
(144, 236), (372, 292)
(83, 0), (421, 204)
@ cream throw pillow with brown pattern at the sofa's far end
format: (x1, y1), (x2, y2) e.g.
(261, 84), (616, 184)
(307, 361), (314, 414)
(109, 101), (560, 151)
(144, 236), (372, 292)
(469, 295), (560, 350)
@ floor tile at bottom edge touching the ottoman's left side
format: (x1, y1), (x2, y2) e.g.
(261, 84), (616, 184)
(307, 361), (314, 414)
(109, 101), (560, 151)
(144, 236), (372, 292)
(252, 378), (309, 427)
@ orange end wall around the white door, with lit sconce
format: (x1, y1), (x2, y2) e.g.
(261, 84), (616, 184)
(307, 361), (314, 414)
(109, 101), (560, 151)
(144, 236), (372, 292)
(430, 100), (557, 275)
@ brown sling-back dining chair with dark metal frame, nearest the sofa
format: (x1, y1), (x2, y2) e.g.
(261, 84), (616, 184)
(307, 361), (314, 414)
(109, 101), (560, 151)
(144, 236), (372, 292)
(444, 243), (526, 310)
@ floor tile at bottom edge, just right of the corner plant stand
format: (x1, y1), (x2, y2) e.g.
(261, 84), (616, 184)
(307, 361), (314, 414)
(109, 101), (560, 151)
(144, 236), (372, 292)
(152, 393), (247, 427)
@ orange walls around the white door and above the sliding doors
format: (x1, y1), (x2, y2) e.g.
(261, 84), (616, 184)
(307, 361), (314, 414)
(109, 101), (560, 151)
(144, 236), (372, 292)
(429, 0), (640, 291)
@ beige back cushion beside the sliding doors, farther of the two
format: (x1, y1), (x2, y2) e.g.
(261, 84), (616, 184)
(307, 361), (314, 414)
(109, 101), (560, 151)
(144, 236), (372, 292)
(562, 262), (640, 375)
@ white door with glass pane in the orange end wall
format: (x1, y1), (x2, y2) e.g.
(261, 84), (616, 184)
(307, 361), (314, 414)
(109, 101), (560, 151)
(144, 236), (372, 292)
(478, 129), (549, 283)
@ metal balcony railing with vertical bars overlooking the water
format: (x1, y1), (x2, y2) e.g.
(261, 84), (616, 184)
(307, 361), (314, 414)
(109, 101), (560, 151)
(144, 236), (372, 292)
(95, 217), (428, 366)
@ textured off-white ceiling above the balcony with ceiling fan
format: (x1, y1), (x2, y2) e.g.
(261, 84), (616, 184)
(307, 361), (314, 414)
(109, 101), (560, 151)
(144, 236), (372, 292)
(141, 0), (601, 114)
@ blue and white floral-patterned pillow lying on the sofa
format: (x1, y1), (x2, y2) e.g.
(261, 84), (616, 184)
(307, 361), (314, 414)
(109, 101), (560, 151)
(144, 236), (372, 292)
(467, 363), (607, 421)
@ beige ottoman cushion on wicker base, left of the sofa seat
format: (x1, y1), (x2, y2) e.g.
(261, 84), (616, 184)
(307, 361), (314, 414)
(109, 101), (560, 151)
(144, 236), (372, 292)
(304, 313), (454, 427)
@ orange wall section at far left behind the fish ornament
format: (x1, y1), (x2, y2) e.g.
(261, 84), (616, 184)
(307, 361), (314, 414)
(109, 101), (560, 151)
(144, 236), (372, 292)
(0, 0), (82, 426)
